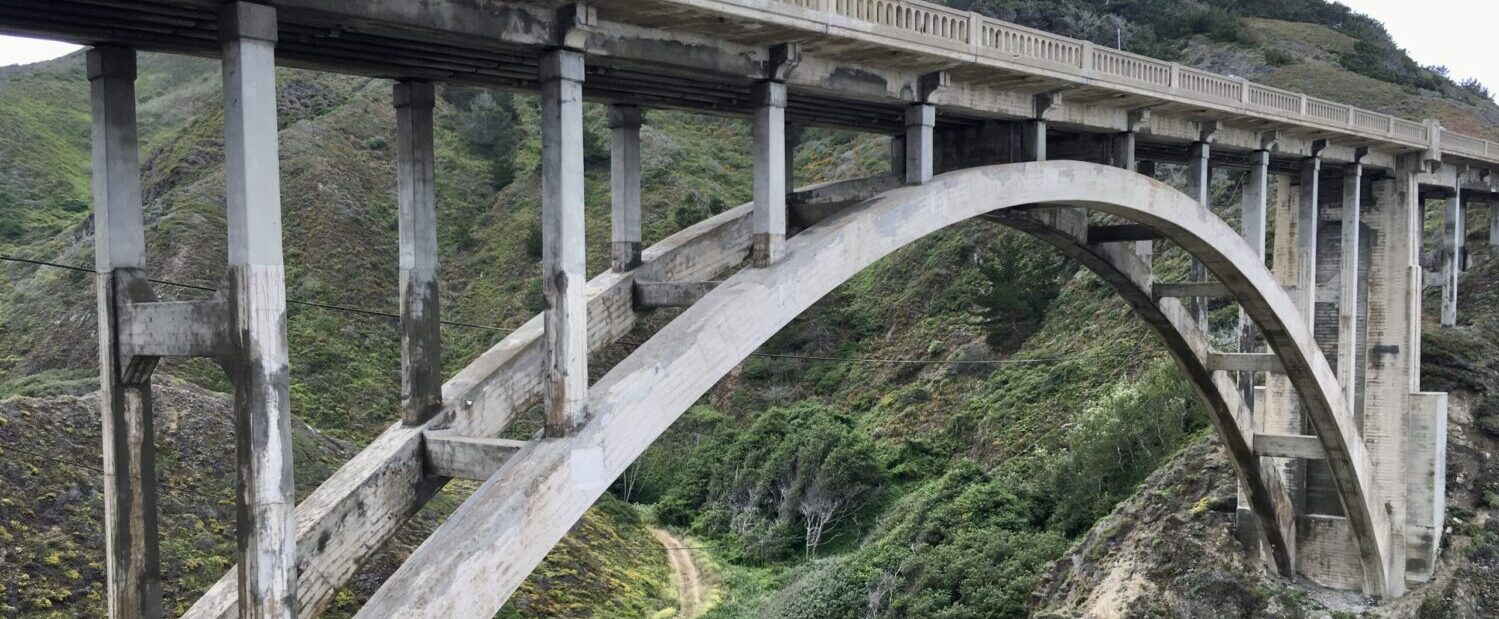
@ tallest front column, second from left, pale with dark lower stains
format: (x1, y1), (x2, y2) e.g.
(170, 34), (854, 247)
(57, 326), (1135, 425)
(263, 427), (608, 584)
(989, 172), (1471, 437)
(219, 1), (297, 619)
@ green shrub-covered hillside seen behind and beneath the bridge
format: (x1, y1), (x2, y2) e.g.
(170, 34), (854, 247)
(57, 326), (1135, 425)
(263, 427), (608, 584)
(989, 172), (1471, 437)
(0, 0), (1499, 619)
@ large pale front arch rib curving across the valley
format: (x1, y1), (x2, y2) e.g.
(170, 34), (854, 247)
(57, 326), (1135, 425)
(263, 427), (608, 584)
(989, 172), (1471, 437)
(358, 162), (1399, 618)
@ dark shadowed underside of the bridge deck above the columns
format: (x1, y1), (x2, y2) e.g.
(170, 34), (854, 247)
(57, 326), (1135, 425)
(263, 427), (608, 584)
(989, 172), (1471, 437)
(0, 0), (1475, 165)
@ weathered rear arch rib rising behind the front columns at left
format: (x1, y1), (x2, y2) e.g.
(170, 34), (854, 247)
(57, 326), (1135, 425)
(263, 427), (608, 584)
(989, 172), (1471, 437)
(184, 196), (751, 619)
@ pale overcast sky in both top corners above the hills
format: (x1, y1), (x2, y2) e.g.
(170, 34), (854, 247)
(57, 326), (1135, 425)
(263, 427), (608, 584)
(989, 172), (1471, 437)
(0, 0), (1499, 91)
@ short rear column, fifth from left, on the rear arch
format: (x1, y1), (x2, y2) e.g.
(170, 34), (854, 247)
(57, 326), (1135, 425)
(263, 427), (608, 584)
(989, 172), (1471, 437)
(609, 105), (642, 271)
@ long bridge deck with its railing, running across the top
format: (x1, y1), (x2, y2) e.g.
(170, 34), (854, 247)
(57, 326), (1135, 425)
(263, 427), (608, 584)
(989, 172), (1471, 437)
(0, 0), (1499, 166)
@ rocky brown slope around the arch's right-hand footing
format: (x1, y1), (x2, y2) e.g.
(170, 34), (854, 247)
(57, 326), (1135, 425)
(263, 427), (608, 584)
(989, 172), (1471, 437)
(1034, 235), (1499, 619)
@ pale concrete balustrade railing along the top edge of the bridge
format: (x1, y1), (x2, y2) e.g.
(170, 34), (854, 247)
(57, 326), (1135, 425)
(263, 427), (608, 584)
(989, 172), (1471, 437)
(767, 0), (1499, 162)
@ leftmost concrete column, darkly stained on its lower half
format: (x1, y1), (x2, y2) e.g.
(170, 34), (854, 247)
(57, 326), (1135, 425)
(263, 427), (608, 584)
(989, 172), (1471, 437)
(87, 46), (162, 619)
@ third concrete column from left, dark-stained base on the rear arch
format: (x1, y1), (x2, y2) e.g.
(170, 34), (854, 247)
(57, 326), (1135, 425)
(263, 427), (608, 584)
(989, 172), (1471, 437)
(393, 81), (442, 426)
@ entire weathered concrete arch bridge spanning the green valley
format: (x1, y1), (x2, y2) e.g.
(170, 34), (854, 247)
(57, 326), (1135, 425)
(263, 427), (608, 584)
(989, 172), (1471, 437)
(0, 0), (1499, 618)
